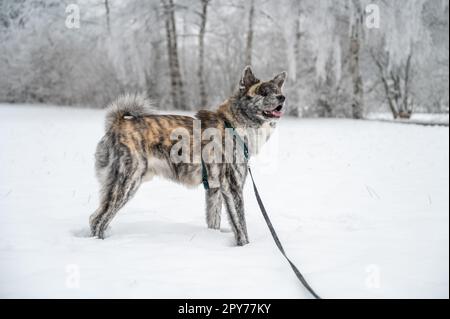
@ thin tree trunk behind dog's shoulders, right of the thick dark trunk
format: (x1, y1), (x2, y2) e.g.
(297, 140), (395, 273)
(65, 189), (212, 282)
(198, 0), (210, 107)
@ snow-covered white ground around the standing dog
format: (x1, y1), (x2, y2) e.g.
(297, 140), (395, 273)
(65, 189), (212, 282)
(0, 105), (449, 298)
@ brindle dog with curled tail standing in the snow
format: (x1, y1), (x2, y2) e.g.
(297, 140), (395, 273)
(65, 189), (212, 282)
(89, 67), (287, 246)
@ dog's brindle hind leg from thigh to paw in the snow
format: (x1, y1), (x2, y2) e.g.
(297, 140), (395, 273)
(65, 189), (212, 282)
(90, 146), (147, 239)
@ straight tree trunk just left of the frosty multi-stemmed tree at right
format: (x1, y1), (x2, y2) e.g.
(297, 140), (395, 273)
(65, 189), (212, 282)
(350, 0), (364, 119)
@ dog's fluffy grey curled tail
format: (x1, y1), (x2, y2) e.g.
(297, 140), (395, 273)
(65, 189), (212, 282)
(105, 94), (153, 131)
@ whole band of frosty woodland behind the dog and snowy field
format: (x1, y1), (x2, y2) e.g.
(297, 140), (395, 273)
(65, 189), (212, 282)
(0, 0), (449, 118)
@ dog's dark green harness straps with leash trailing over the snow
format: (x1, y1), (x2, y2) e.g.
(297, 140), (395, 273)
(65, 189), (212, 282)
(202, 122), (321, 299)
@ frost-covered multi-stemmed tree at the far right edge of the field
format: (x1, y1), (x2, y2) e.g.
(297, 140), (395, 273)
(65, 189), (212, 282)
(370, 0), (448, 118)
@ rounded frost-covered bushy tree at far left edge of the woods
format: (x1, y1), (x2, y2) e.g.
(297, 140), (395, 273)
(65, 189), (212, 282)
(0, 0), (119, 106)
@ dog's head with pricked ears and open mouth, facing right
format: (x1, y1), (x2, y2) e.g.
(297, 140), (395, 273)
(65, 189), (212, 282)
(236, 66), (287, 124)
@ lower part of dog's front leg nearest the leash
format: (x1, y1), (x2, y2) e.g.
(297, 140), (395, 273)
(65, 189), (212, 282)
(222, 186), (249, 246)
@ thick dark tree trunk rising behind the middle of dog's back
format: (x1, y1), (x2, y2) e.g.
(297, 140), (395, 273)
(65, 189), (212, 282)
(161, 0), (188, 110)
